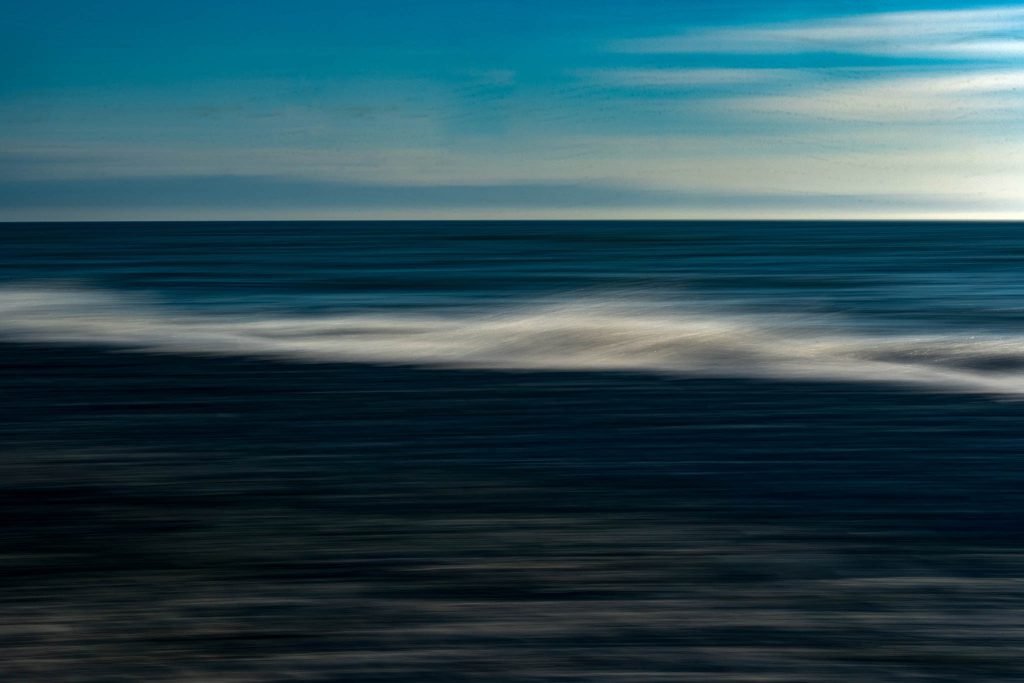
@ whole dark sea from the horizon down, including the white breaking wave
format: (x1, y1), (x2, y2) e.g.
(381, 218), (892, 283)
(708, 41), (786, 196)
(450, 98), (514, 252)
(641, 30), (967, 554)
(0, 223), (1024, 683)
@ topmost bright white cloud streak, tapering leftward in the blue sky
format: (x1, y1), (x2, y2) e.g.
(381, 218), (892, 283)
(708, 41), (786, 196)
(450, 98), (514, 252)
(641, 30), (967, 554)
(614, 6), (1024, 58)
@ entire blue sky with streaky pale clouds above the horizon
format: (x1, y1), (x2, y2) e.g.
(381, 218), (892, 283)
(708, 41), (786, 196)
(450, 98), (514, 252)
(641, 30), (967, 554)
(0, 0), (1024, 221)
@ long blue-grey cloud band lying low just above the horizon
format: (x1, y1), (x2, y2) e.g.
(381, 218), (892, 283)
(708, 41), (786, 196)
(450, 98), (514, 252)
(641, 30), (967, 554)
(0, 176), (1003, 220)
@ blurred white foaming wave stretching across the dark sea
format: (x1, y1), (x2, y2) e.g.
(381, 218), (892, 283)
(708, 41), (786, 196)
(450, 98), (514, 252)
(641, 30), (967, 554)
(0, 287), (1024, 395)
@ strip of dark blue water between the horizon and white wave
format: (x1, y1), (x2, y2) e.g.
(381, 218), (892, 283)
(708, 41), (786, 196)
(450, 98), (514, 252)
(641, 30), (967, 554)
(6, 221), (1024, 325)
